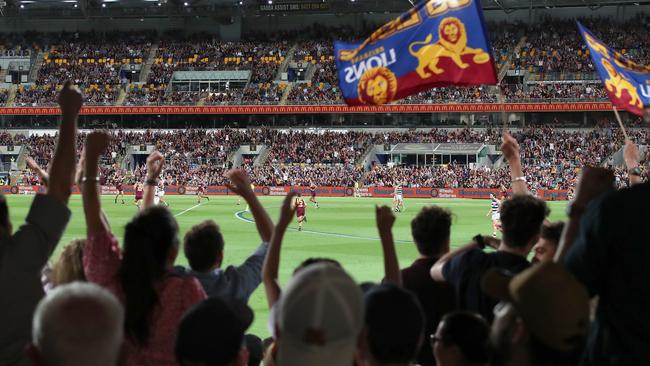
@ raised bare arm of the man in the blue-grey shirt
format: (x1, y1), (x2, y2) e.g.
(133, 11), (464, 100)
(226, 169), (273, 242)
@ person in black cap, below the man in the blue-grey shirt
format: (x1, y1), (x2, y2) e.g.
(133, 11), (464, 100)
(174, 297), (253, 366)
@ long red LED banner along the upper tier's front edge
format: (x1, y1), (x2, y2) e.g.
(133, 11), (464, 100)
(0, 102), (612, 115)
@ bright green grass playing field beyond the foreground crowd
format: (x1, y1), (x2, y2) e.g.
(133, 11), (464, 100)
(7, 196), (566, 337)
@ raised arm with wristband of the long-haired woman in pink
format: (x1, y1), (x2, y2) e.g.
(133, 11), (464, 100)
(81, 131), (110, 238)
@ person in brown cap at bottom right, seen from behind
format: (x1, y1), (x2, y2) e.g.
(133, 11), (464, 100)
(481, 262), (589, 366)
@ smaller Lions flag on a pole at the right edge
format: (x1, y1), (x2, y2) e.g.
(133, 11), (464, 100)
(578, 22), (650, 116)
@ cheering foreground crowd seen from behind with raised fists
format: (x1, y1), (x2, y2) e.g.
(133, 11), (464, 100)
(0, 84), (650, 366)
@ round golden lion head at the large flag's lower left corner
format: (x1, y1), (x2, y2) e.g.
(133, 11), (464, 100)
(357, 67), (397, 104)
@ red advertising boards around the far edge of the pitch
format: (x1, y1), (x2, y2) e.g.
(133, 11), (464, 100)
(0, 186), (568, 201)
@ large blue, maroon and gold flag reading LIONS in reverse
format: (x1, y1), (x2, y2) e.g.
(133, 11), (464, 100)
(334, 0), (497, 105)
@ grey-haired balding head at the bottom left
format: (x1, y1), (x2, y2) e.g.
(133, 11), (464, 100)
(28, 282), (124, 366)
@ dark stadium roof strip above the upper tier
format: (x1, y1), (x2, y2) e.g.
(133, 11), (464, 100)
(0, 0), (650, 17)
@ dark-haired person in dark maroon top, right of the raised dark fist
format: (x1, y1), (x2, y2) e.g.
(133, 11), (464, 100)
(402, 206), (456, 366)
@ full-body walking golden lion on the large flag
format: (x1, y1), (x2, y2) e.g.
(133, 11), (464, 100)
(409, 17), (490, 79)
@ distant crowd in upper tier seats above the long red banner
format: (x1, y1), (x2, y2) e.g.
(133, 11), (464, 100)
(5, 15), (650, 106)
